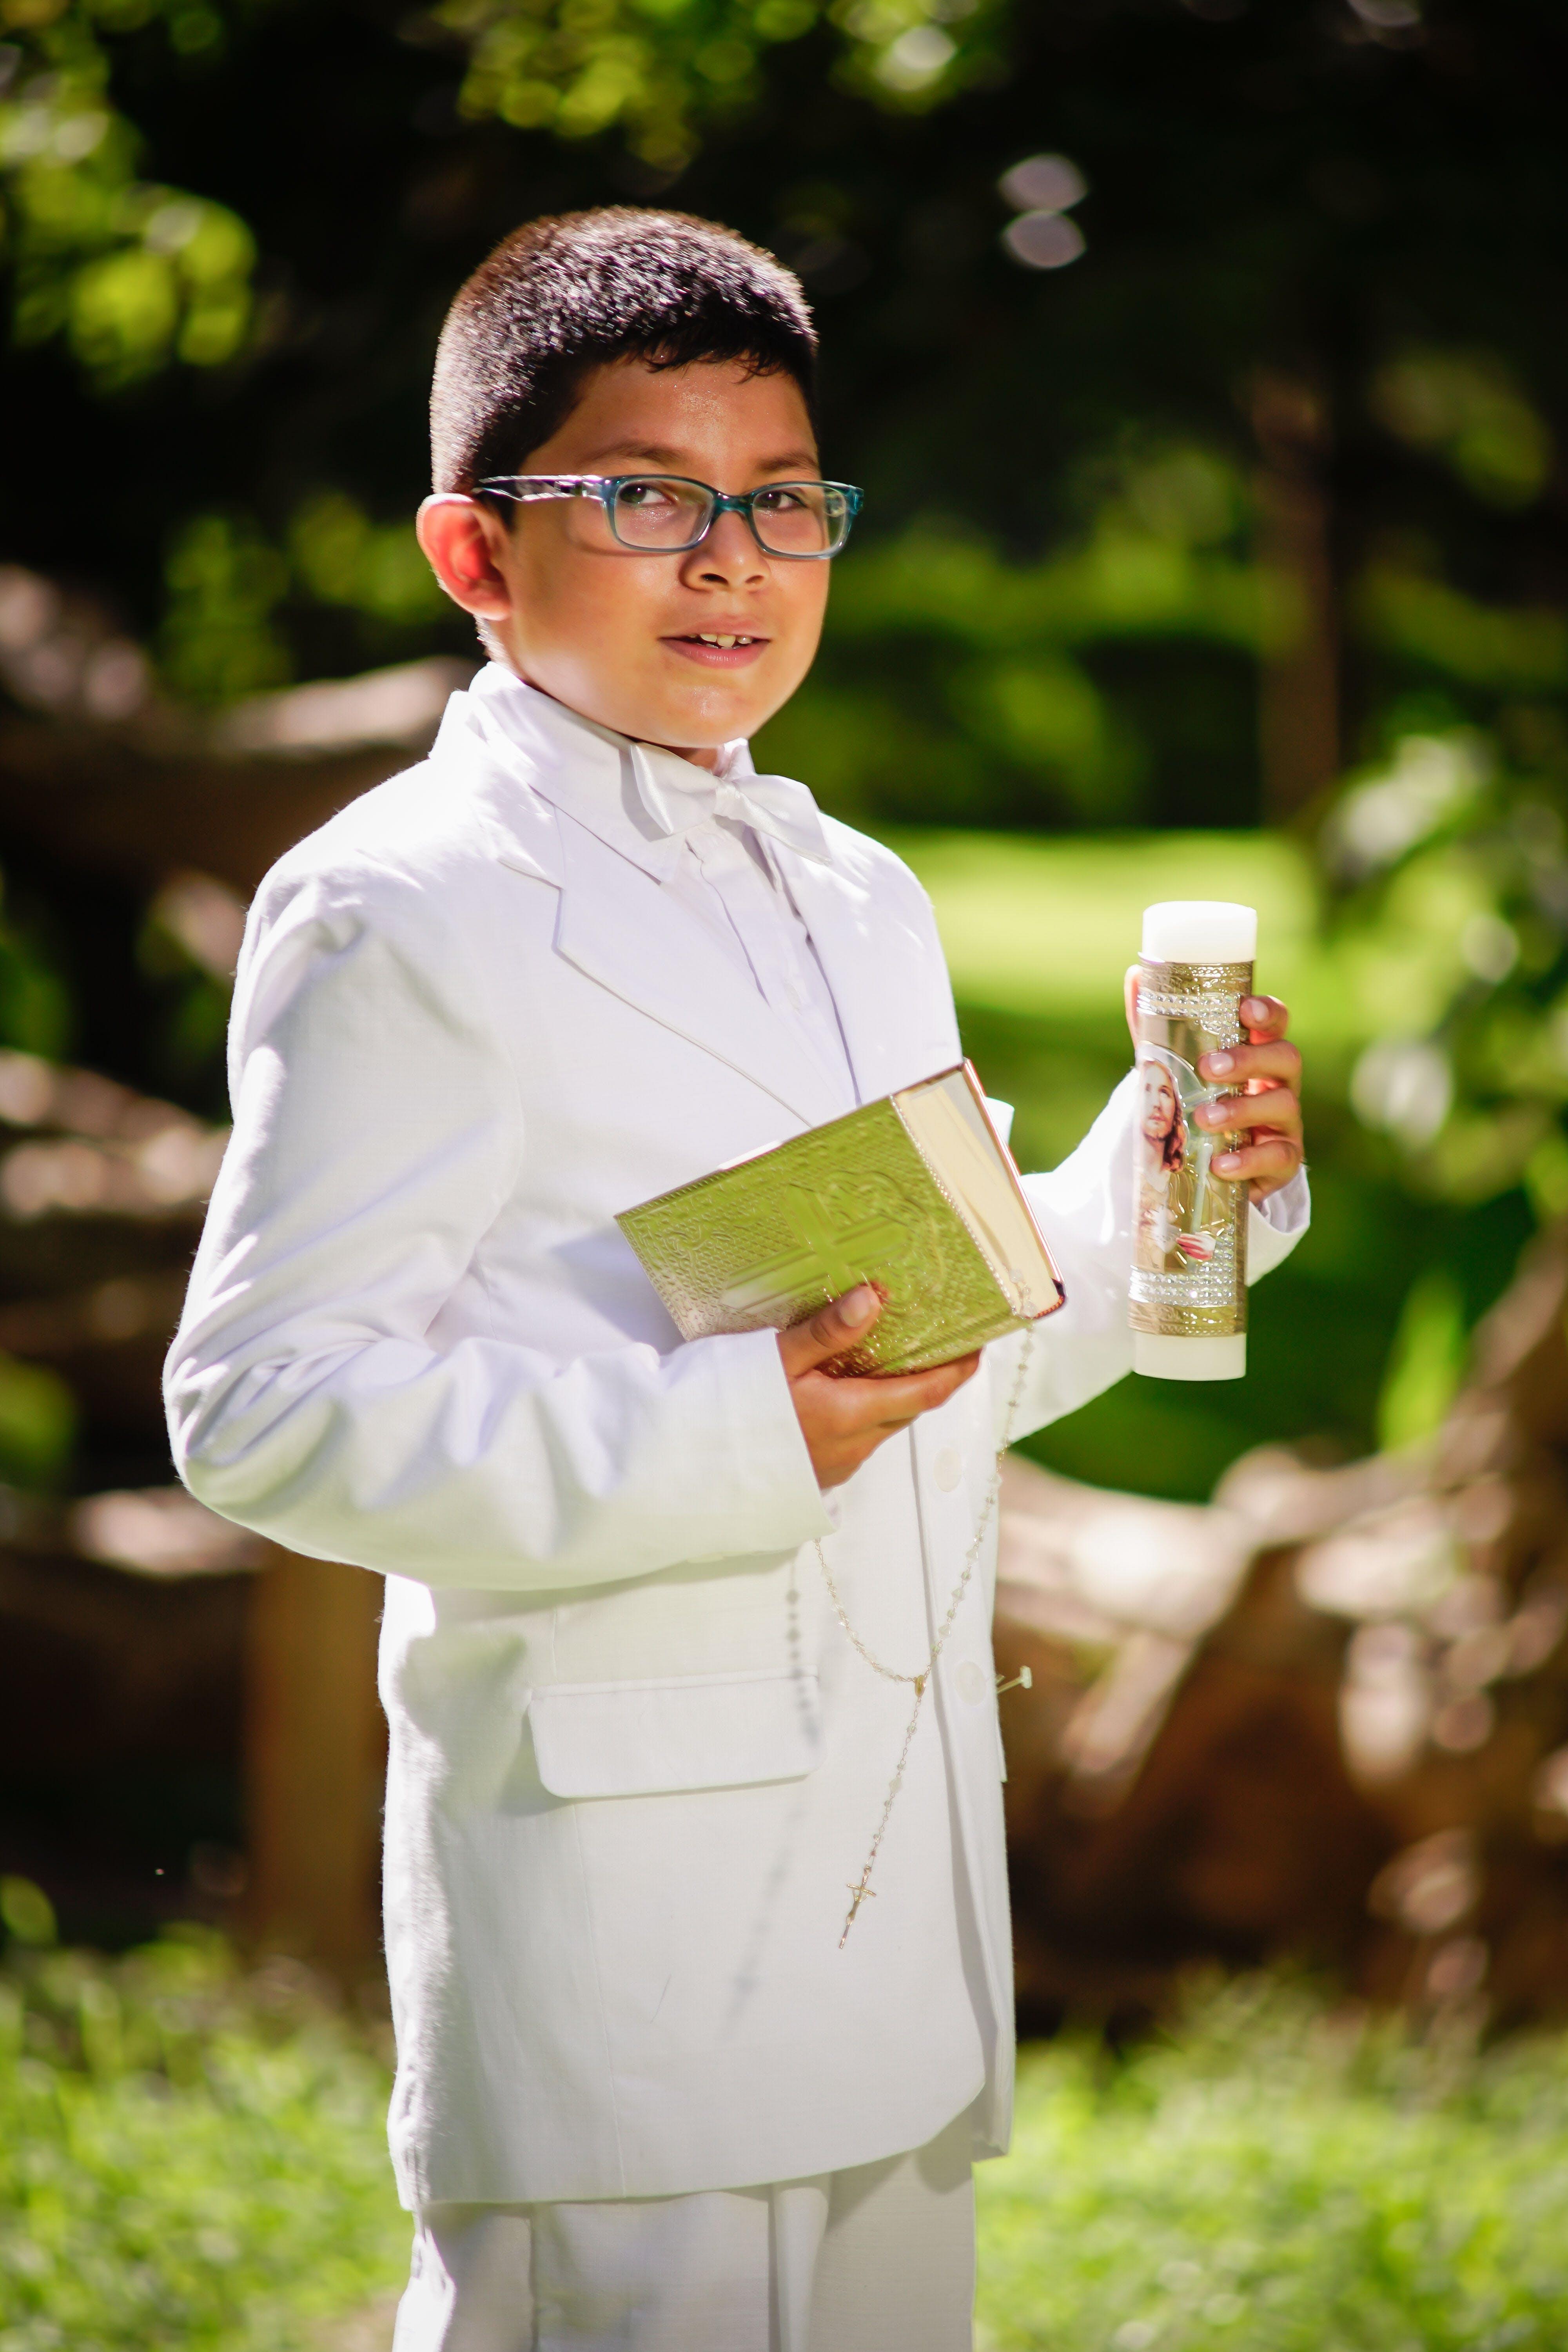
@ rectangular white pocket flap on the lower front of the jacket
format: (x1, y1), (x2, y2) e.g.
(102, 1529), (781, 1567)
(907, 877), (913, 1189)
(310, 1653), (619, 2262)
(529, 1668), (823, 1797)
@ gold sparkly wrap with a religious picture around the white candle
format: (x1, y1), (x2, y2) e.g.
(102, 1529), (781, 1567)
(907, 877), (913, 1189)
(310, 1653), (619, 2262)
(1129, 955), (1253, 1381)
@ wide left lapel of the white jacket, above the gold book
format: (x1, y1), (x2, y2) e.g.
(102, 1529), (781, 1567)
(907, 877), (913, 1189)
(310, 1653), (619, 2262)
(555, 809), (844, 1127)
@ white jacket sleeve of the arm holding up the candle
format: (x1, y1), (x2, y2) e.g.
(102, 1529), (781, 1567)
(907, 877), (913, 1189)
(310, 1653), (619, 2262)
(987, 1073), (1312, 1444)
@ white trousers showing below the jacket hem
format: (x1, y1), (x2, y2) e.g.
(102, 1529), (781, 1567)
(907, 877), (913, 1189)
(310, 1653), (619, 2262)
(392, 2117), (976, 2352)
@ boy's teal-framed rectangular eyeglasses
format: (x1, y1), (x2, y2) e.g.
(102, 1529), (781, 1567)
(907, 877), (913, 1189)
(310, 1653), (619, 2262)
(475, 473), (860, 562)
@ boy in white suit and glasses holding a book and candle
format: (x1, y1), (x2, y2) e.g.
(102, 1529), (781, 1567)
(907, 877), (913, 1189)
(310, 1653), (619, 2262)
(167, 209), (1305, 2352)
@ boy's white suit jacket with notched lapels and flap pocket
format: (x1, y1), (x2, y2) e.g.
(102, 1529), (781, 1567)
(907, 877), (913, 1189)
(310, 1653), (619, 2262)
(167, 670), (1290, 2206)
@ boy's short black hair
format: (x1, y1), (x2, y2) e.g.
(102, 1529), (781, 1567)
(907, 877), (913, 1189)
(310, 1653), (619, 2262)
(430, 205), (816, 489)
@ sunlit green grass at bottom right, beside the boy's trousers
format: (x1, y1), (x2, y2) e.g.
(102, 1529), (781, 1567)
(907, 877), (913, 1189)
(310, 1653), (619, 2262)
(976, 1983), (1568, 2352)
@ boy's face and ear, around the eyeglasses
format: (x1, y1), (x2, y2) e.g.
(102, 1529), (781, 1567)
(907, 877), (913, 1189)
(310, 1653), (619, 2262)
(418, 360), (830, 764)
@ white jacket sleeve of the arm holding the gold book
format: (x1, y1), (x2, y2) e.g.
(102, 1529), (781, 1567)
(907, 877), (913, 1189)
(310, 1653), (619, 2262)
(165, 875), (830, 1590)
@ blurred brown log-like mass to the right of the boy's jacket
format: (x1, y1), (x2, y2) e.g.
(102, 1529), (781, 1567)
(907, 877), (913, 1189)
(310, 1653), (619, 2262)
(997, 1228), (1568, 2023)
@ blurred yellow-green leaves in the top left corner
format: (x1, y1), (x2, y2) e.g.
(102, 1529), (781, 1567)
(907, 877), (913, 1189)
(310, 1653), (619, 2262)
(0, 0), (256, 393)
